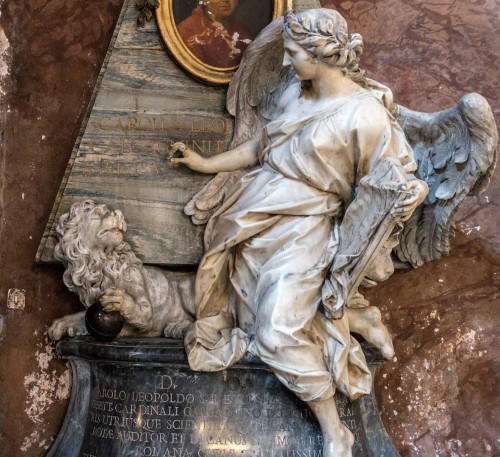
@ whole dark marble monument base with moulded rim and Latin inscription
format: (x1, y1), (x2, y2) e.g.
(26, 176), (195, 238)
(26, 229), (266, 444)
(47, 337), (398, 457)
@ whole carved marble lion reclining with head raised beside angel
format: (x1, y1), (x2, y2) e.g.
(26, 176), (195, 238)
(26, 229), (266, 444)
(48, 200), (194, 340)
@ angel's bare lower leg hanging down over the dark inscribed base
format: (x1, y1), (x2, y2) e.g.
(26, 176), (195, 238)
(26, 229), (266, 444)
(307, 397), (354, 457)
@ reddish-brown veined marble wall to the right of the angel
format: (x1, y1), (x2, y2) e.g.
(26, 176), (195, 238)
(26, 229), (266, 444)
(322, 0), (500, 457)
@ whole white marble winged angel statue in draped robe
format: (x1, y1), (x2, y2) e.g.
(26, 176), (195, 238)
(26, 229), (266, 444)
(170, 9), (496, 457)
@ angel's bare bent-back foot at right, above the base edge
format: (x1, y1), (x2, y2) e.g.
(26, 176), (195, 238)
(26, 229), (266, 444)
(347, 306), (394, 359)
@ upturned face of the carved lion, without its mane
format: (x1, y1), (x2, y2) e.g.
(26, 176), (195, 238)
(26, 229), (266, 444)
(80, 205), (127, 251)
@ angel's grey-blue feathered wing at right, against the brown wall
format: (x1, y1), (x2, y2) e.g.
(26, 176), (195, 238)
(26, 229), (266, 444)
(394, 93), (498, 267)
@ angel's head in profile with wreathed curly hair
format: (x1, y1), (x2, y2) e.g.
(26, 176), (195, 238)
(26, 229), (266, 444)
(283, 8), (365, 85)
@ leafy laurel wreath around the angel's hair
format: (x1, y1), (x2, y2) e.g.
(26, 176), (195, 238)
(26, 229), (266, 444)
(285, 12), (363, 67)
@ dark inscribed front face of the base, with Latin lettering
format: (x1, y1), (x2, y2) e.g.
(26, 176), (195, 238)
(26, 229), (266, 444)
(81, 366), (368, 457)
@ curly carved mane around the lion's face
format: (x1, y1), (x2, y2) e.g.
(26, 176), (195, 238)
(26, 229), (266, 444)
(54, 200), (142, 307)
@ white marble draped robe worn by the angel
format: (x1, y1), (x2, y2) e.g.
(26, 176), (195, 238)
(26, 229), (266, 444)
(185, 84), (414, 401)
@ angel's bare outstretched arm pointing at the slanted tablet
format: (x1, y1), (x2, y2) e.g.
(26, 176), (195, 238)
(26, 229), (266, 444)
(170, 137), (259, 173)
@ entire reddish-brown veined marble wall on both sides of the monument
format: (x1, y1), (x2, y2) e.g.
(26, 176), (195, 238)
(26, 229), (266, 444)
(0, 0), (500, 457)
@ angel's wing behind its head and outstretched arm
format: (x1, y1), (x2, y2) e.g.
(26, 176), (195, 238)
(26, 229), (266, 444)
(184, 17), (294, 225)
